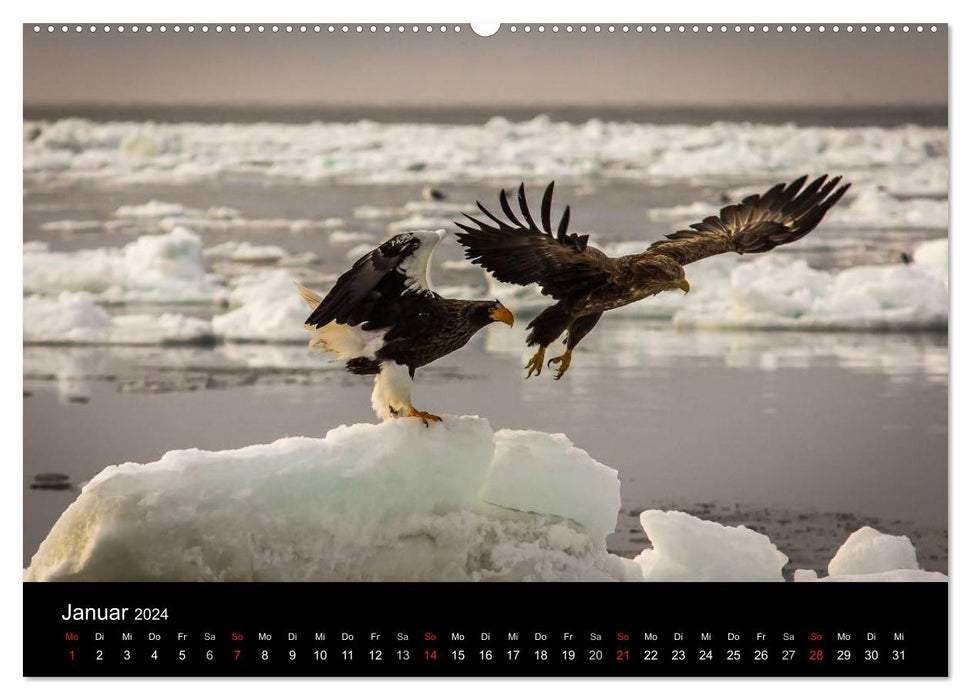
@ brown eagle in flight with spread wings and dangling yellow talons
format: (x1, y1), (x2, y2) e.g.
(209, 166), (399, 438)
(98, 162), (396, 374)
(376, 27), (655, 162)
(456, 175), (850, 379)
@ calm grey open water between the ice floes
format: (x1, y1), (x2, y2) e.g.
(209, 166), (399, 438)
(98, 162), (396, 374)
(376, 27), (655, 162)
(23, 160), (948, 572)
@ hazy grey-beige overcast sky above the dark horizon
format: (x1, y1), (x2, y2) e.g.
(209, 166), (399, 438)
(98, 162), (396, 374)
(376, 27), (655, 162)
(24, 25), (947, 106)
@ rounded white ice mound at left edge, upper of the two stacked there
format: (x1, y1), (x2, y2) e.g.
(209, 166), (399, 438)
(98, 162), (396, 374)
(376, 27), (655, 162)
(24, 228), (219, 303)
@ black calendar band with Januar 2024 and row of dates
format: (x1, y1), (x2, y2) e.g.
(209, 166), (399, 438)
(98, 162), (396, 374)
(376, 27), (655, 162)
(24, 583), (948, 677)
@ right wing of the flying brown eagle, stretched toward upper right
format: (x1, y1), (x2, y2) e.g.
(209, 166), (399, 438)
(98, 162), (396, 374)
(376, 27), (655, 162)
(643, 175), (850, 265)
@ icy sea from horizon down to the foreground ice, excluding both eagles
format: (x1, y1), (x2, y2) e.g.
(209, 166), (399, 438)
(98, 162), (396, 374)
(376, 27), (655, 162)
(24, 113), (948, 572)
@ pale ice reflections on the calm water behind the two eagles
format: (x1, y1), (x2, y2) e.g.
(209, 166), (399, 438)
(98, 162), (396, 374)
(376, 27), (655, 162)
(24, 319), (948, 403)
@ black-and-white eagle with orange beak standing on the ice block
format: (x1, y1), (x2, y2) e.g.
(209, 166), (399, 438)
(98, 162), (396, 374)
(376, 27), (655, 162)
(298, 231), (513, 425)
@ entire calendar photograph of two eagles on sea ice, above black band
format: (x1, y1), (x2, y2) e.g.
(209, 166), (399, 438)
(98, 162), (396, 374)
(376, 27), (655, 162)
(22, 23), (949, 600)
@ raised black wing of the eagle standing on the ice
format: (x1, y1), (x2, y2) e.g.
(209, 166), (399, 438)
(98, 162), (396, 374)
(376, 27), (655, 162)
(306, 235), (421, 328)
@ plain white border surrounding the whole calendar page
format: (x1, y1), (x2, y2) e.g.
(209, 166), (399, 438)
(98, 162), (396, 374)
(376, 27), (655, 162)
(0, 0), (971, 700)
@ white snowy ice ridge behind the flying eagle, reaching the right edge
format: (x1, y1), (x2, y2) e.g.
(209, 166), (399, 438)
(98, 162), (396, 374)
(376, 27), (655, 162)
(486, 238), (948, 330)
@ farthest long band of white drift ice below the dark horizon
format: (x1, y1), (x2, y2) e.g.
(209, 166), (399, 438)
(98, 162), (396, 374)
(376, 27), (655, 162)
(24, 116), (948, 193)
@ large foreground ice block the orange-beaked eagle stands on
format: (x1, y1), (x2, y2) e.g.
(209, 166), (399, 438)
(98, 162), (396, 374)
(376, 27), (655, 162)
(25, 417), (640, 581)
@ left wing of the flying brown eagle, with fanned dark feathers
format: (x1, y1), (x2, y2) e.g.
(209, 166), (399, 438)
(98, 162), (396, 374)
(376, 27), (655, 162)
(455, 182), (613, 298)
